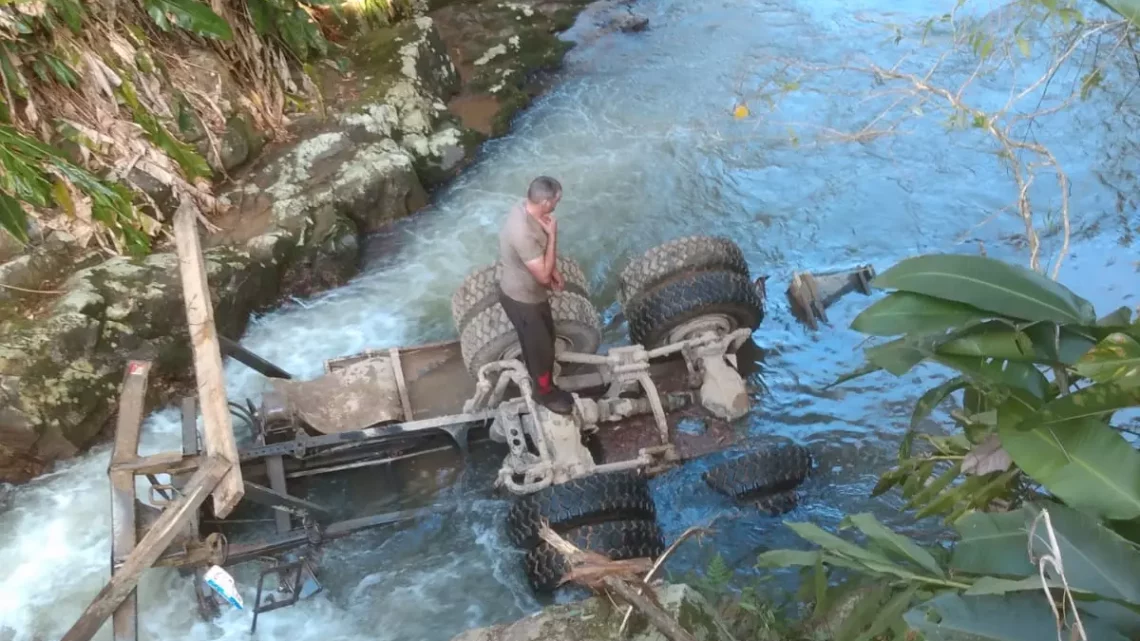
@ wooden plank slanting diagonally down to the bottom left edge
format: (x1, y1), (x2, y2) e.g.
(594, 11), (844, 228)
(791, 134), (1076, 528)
(62, 457), (233, 641)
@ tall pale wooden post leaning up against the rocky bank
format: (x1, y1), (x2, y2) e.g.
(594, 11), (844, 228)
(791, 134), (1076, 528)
(174, 198), (245, 519)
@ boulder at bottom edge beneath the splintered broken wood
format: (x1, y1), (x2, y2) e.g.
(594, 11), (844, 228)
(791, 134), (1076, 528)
(451, 584), (734, 641)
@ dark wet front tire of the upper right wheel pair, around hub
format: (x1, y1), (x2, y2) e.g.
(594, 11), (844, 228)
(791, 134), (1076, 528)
(625, 271), (764, 349)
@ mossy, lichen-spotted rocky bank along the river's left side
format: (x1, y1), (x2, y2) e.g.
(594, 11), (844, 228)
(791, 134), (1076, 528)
(0, 0), (644, 482)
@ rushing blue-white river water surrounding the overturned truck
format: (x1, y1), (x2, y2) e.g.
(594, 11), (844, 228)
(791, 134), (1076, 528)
(0, 0), (1140, 641)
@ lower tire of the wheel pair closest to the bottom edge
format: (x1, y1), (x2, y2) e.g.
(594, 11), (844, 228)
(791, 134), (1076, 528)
(526, 519), (665, 592)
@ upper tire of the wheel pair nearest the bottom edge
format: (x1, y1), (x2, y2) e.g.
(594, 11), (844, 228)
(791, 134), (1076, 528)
(506, 472), (657, 550)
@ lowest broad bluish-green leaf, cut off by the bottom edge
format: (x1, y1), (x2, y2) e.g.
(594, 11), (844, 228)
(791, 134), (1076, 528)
(904, 592), (1126, 641)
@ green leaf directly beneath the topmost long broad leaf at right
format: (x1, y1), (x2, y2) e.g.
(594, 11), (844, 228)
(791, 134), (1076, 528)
(850, 292), (993, 336)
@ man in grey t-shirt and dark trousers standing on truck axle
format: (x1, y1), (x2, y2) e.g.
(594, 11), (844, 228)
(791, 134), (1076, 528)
(499, 176), (573, 414)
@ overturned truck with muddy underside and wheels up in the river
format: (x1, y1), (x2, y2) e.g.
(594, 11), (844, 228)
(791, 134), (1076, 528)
(65, 230), (871, 640)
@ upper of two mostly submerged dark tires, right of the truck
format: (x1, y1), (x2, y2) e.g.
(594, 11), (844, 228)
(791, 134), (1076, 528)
(702, 445), (812, 499)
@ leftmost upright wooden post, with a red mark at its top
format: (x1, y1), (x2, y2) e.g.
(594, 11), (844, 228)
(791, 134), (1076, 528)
(108, 360), (150, 641)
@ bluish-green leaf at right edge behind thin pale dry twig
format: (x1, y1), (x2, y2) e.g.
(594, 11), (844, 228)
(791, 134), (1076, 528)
(1026, 504), (1140, 606)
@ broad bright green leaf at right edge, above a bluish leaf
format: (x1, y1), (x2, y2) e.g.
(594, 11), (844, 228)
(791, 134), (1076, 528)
(998, 417), (1140, 520)
